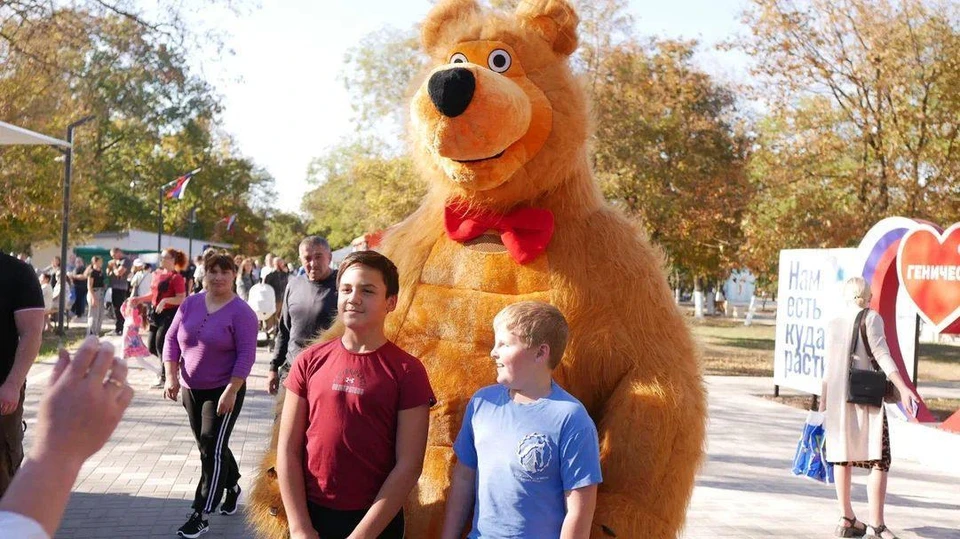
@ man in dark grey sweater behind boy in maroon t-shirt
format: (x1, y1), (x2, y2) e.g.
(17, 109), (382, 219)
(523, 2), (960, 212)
(267, 236), (337, 395)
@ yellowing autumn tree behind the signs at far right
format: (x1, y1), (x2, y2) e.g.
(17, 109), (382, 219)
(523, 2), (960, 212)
(739, 0), (960, 273)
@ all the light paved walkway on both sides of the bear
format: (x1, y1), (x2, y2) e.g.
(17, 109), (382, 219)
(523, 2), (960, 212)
(26, 342), (960, 539)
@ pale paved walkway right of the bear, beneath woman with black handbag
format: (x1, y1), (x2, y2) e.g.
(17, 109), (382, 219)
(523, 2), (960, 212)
(683, 376), (960, 539)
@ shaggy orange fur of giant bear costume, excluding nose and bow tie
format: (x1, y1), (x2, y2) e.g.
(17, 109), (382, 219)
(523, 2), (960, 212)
(248, 0), (706, 539)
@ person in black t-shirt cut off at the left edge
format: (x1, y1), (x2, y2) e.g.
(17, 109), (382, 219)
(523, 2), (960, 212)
(0, 253), (44, 495)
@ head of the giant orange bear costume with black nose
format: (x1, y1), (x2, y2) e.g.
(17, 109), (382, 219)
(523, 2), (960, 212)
(411, 0), (587, 209)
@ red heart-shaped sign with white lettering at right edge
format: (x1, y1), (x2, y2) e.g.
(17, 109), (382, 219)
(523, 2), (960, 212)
(897, 223), (960, 332)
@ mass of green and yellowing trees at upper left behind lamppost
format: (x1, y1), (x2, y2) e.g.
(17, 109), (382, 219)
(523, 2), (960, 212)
(0, 1), (273, 255)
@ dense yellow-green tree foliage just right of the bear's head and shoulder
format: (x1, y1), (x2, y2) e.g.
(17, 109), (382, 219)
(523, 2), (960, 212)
(593, 40), (752, 288)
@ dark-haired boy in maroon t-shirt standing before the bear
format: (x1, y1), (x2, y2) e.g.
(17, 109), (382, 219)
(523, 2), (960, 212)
(277, 251), (435, 539)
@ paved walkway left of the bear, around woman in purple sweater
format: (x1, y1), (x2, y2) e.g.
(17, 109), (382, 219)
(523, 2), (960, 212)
(24, 337), (273, 539)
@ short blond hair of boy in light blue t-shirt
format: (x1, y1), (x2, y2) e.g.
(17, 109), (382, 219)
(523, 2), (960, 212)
(493, 301), (569, 369)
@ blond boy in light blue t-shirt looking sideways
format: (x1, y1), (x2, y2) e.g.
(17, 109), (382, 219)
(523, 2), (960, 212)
(441, 301), (602, 539)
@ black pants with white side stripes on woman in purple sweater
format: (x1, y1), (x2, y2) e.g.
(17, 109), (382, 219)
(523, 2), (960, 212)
(183, 384), (247, 513)
